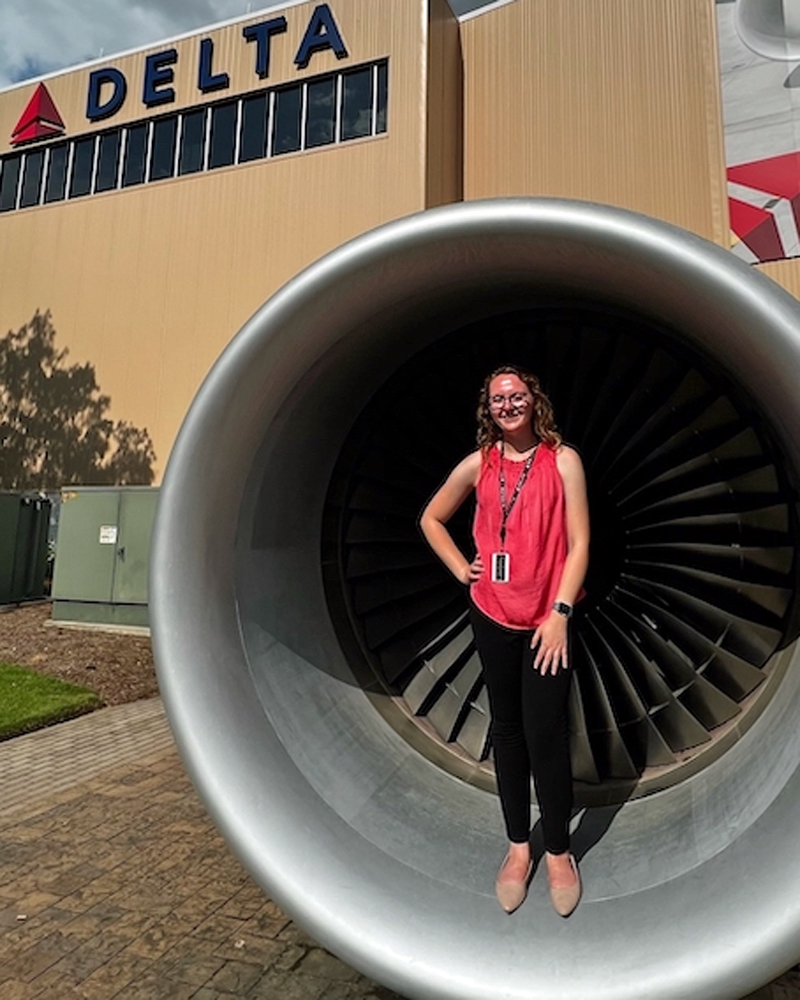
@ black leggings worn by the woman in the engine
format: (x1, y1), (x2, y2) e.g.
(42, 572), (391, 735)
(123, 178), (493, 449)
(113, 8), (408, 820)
(470, 607), (572, 854)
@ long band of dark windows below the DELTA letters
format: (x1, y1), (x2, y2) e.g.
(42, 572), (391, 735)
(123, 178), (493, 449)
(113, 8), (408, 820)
(0, 59), (389, 212)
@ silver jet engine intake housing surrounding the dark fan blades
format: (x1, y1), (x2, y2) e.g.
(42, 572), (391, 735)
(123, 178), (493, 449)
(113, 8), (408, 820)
(151, 199), (800, 1000)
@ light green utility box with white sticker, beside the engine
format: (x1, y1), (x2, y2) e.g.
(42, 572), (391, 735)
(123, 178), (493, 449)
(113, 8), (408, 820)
(53, 486), (158, 625)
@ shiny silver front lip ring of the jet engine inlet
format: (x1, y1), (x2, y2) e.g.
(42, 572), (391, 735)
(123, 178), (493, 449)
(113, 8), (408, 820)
(150, 199), (800, 1000)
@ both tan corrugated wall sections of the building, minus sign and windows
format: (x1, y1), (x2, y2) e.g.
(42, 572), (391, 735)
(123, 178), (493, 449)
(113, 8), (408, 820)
(7, 0), (800, 486)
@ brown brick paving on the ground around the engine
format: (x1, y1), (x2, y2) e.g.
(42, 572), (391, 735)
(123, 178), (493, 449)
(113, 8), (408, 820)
(0, 699), (800, 1000)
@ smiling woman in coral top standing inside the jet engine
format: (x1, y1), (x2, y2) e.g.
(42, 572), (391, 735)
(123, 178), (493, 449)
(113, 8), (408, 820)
(420, 366), (589, 916)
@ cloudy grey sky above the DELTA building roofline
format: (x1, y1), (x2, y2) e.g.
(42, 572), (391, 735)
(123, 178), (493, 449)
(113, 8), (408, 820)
(0, 0), (485, 89)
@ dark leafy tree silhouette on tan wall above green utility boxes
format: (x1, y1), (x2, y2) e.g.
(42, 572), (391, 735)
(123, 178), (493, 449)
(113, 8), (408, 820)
(0, 309), (156, 491)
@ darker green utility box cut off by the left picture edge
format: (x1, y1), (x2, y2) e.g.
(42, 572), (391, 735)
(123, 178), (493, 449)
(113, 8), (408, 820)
(0, 493), (51, 604)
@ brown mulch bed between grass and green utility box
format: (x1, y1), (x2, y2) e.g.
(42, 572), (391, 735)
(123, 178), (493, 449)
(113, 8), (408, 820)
(0, 602), (158, 705)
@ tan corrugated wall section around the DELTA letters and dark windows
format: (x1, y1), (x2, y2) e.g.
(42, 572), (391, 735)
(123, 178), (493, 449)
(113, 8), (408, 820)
(0, 0), (434, 477)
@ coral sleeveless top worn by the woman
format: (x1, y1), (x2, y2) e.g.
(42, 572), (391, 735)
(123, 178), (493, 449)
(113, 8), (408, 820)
(470, 442), (567, 629)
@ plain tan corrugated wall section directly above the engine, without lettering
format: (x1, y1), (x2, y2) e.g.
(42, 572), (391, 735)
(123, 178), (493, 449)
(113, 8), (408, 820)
(462, 0), (728, 245)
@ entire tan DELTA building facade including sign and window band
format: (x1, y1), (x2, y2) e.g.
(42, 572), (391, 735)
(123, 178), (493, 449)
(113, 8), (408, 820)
(0, 0), (800, 488)
